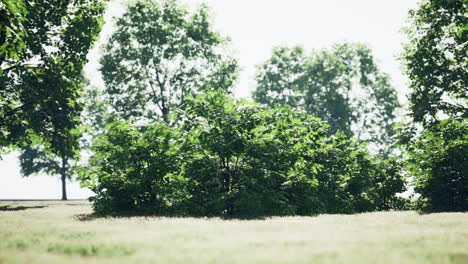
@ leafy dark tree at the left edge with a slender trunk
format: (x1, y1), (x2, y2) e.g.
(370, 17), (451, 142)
(0, 0), (105, 199)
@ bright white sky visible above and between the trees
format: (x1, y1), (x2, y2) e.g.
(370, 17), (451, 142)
(0, 0), (418, 199)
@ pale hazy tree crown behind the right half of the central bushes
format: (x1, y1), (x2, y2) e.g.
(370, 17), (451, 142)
(253, 43), (399, 152)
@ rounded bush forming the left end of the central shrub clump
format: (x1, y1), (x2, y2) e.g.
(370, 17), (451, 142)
(81, 122), (184, 214)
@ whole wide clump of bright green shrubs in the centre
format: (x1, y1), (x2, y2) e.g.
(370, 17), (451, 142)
(83, 92), (405, 217)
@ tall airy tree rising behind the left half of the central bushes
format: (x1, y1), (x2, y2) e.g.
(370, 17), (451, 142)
(101, 0), (238, 122)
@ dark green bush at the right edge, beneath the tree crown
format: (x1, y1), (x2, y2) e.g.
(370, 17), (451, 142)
(408, 118), (468, 212)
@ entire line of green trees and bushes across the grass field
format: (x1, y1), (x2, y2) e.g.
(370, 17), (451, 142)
(0, 0), (468, 214)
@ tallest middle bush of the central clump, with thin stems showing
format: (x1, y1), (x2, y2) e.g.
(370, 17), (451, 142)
(181, 93), (327, 216)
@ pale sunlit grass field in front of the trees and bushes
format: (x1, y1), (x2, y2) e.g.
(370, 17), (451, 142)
(0, 201), (468, 264)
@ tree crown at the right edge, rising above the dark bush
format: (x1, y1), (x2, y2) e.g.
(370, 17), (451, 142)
(402, 0), (468, 127)
